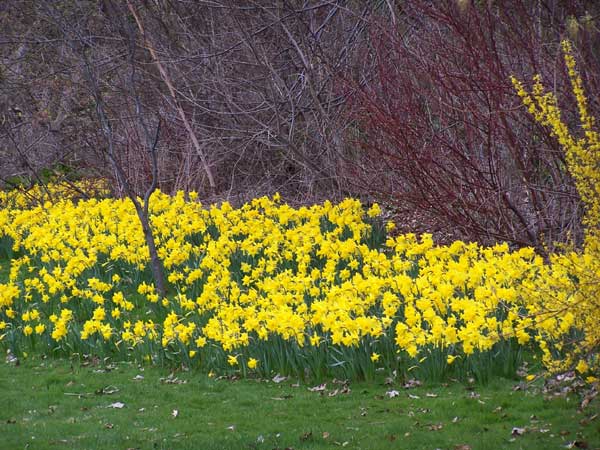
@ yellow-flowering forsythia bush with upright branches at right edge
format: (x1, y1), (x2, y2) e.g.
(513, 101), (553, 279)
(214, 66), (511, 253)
(512, 41), (600, 372)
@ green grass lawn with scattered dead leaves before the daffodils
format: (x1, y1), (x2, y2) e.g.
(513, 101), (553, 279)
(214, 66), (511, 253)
(0, 357), (600, 450)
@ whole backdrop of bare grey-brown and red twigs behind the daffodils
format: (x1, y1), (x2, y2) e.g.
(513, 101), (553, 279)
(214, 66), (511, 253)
(0, 0), (600, 251)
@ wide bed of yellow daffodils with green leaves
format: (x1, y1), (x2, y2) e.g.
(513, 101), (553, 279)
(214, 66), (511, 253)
(0, 185), (600, 378)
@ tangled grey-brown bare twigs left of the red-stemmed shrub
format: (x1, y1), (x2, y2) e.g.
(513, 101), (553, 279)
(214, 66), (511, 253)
(0, 0), (382, 200)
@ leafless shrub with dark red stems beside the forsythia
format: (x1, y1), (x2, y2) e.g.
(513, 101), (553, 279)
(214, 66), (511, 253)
(354, 0), (600, 252)
